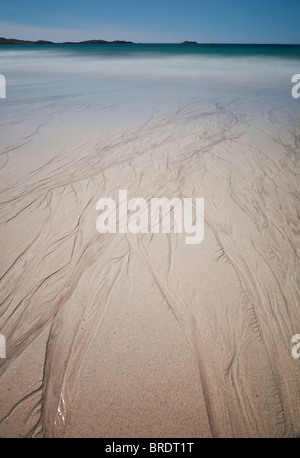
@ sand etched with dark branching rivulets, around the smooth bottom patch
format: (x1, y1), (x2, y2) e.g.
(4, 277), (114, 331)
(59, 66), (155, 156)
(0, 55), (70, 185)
(0, 97), (300, 437)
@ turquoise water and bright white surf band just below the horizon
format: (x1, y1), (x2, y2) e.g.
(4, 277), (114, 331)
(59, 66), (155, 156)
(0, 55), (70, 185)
(0, 45), (300, 85)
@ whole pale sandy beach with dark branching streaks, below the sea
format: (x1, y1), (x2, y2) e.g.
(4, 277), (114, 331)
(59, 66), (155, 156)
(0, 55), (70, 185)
(0, 45), (300, 438)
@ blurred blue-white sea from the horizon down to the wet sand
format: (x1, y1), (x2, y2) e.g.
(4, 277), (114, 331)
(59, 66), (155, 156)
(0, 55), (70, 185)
(0, 43), (300, 147)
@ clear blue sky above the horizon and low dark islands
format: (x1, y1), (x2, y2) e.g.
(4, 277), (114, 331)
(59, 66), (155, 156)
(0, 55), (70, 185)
(0, 0), (300, 43)
